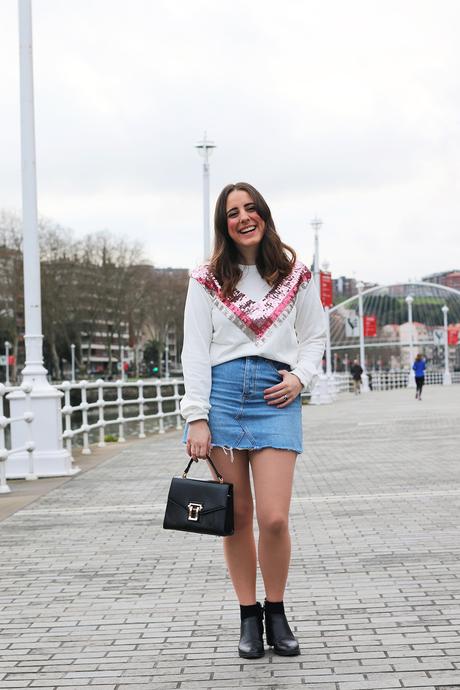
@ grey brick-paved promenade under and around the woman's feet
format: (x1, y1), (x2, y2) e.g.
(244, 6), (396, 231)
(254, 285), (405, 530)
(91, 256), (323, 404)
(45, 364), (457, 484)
(0, 386), (460, 690)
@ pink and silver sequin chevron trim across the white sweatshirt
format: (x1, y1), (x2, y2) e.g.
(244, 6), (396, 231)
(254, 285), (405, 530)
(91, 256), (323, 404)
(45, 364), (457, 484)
(192, 261), (311, 344)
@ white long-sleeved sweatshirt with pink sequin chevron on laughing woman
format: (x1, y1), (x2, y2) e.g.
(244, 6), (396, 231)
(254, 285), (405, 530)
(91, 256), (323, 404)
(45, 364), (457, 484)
(181, 262), (326, 422)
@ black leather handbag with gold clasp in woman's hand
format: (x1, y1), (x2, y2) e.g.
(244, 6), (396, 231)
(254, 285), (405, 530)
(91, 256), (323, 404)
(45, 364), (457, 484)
(163, 455), (234, 537)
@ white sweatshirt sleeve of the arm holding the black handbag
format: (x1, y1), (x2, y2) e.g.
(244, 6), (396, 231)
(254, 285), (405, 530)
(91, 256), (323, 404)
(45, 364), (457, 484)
(180, 278), (212, 422)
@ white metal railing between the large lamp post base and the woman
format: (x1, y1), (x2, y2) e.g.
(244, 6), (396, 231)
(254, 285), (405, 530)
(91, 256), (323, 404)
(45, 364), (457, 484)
(57, 379), (183, 455)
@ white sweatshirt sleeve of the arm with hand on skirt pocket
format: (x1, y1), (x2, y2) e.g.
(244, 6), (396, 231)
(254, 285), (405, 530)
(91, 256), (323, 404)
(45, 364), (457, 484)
(291, 279), (326, 387)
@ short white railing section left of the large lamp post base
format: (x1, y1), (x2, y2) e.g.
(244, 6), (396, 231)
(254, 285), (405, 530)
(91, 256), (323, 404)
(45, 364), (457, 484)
(0, 383), (37, 494)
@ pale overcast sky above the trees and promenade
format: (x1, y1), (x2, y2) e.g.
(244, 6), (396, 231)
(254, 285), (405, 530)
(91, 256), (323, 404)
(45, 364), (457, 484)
(0, 0), (460, 283)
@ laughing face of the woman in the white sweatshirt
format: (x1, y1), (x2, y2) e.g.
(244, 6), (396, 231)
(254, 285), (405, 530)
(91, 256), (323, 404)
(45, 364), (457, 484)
(227, 190), (265, 260)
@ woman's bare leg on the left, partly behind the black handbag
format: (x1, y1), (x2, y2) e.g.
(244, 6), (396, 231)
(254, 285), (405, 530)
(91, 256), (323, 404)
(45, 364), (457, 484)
(211, 447), (257, 606)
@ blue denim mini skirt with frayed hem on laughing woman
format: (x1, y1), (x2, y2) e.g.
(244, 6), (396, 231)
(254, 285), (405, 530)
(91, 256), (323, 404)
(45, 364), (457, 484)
(183, 356), (302, 453)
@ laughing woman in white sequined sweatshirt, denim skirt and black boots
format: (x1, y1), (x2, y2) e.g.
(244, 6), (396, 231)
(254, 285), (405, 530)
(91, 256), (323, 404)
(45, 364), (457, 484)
(181, 183), (325, 659)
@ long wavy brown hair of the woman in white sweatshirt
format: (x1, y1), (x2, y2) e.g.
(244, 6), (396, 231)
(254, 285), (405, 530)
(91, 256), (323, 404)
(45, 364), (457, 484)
(209, 182), (297, 297)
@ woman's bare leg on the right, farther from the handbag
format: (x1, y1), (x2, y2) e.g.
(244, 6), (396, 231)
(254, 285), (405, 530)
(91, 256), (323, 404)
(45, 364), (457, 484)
(250, 448), (297, 601)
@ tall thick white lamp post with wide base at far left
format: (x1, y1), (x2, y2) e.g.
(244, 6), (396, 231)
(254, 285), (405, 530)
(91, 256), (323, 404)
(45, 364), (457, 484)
(6, 0), (73, 478)
